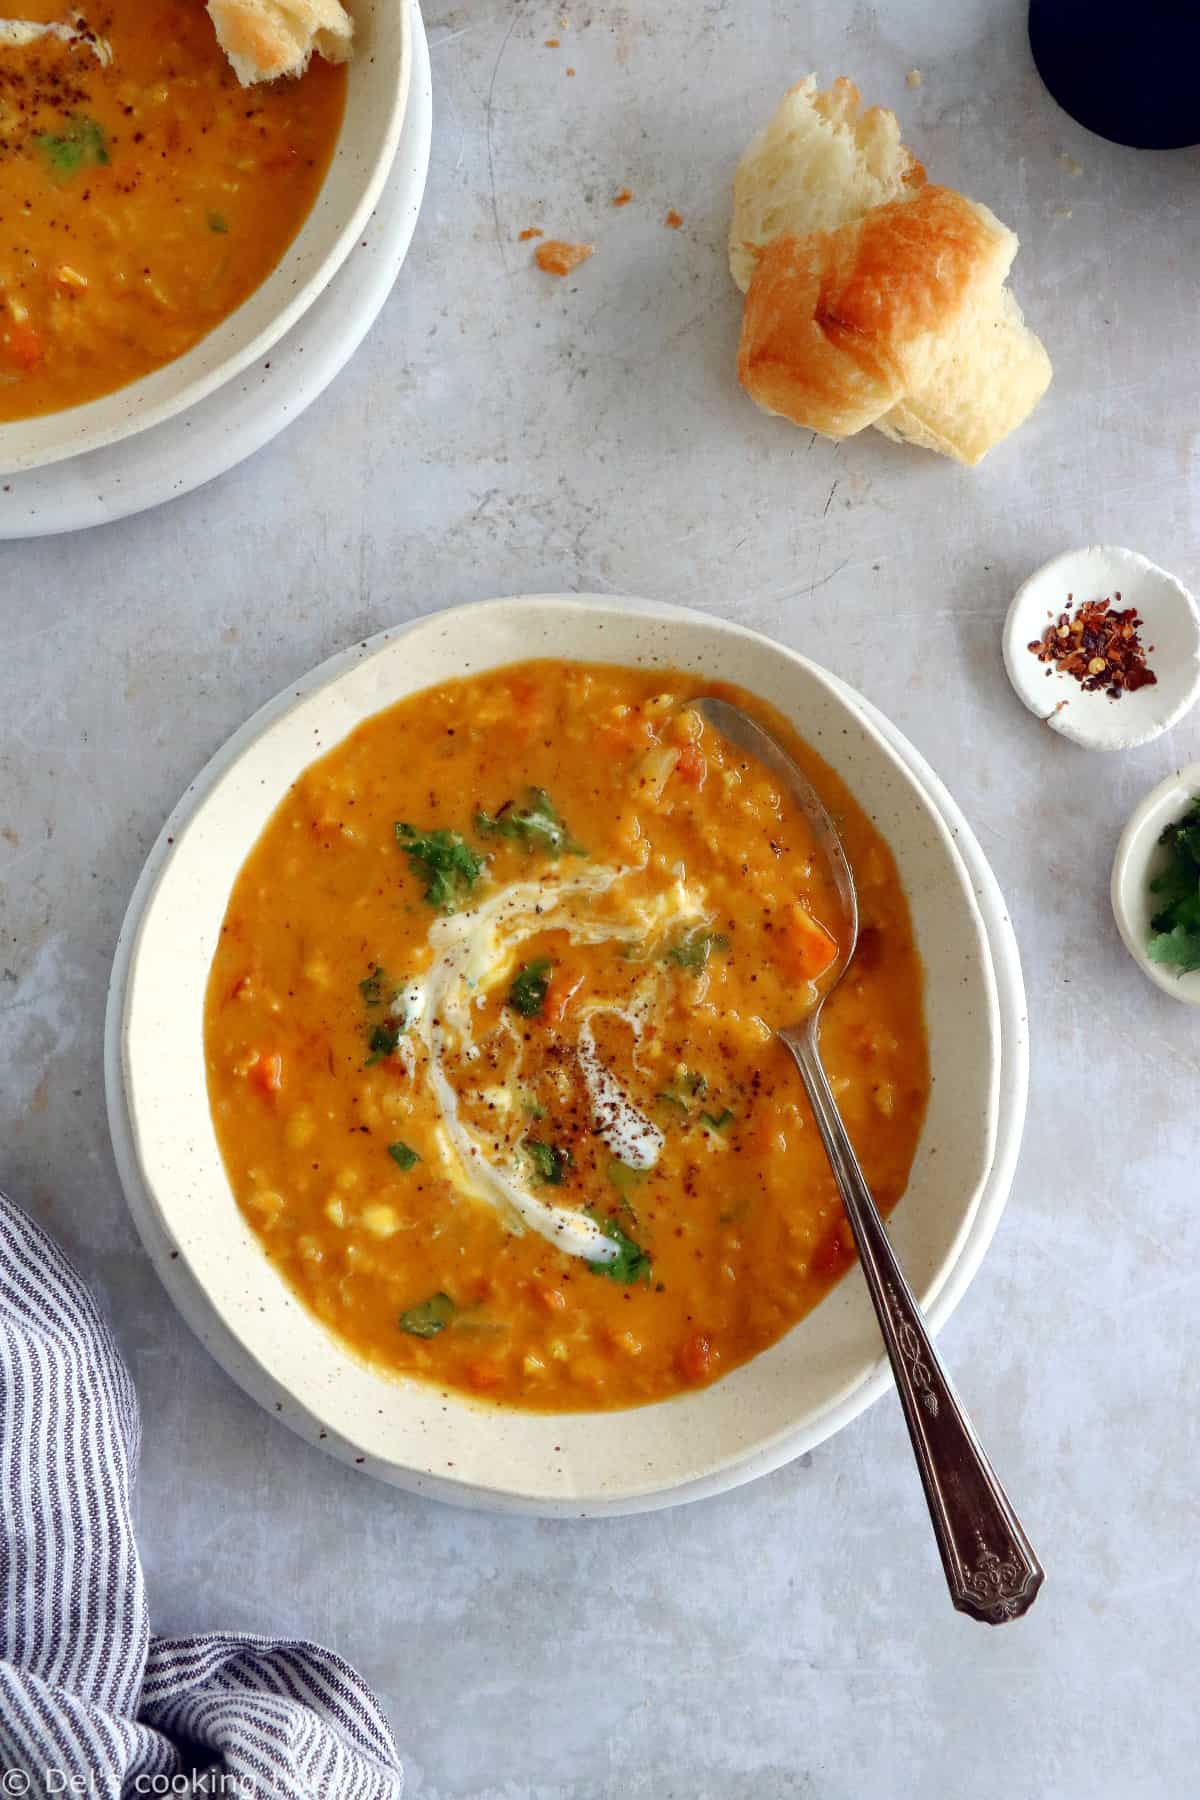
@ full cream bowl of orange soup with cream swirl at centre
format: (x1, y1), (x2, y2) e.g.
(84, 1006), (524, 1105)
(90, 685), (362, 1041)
(110, 598), (1020, 1510)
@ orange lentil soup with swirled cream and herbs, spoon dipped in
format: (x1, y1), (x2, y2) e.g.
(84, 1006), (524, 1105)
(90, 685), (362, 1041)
(207, 662), (928, 1411)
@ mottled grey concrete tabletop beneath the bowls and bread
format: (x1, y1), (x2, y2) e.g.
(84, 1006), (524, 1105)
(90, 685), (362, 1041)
(0, 0), (1200, 1800)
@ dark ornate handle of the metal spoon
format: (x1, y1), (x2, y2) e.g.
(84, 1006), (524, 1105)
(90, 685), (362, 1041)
(781, 1017), (1045, 1625)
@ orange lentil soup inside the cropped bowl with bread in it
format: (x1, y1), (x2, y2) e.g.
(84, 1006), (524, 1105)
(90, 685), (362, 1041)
(0, 0), (345, 421)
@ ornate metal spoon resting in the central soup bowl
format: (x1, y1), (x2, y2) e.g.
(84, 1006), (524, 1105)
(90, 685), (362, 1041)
(694, 698), (1045, 1625)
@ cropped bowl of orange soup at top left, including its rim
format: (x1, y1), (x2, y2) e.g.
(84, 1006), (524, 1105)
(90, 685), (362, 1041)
(0, 0), (410, 473)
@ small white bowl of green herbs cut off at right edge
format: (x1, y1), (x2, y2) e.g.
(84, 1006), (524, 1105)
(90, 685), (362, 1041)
(1112, 763), (1200, 1006)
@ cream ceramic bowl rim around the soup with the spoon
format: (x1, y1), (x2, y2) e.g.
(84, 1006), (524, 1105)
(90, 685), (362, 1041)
(108, 598), (1024, 1512)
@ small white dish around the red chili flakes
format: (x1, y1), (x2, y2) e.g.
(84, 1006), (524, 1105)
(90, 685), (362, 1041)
(1004, 544), (1200, 751)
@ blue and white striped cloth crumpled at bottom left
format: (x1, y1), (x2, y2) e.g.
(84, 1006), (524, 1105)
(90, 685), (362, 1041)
(0, 1193), (403, 1800)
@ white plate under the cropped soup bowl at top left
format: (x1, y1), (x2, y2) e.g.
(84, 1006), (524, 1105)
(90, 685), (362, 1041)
(0, 0), (434, 544)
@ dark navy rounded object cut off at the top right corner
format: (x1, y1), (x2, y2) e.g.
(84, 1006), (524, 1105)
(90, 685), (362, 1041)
(1029, 0), (1200, 149)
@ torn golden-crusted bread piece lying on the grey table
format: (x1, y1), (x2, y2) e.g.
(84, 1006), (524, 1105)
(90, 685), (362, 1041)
(729, 76), (1052, 464)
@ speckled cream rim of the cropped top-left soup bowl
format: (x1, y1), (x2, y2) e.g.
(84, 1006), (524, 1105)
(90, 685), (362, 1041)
(0, 0), (412, 475)
